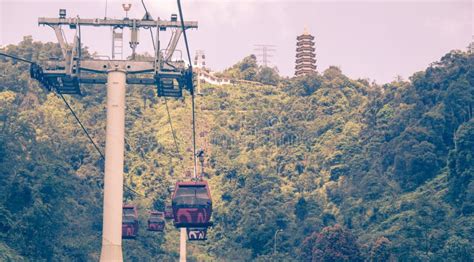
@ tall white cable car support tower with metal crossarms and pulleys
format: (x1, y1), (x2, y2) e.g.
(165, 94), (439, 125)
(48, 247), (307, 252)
(35, 5), (197, 261)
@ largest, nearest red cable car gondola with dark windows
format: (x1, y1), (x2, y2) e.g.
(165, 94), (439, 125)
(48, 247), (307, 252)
(171, 181), (212, 228)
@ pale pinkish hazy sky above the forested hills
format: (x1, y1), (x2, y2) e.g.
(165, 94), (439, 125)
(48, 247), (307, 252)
(0, 0), (474, 83)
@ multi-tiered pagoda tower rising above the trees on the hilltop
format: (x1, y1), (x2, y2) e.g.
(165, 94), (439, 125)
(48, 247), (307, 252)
(295, 29), (316, 76)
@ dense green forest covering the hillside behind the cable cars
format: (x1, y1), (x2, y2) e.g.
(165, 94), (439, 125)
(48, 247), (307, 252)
(0, 37), (474, 261)
